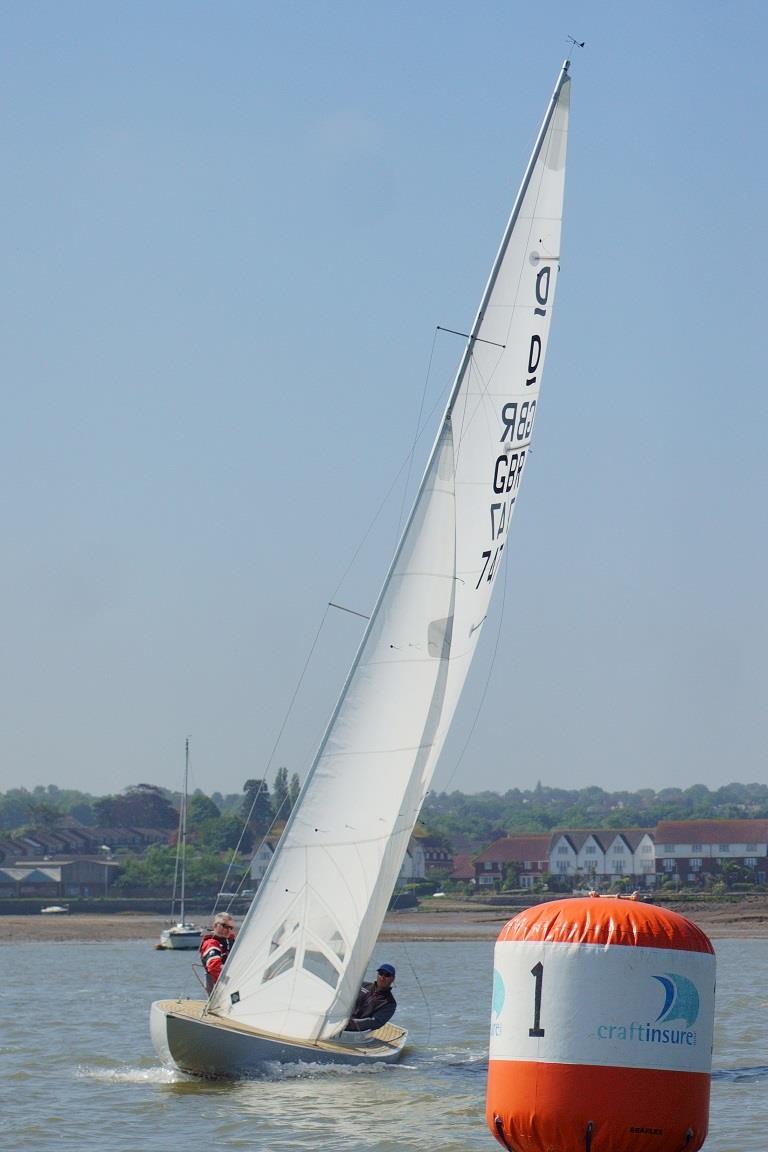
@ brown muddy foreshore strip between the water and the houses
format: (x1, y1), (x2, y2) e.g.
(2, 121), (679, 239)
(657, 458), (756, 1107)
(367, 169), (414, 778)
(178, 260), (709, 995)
(6, 895), (768, 947)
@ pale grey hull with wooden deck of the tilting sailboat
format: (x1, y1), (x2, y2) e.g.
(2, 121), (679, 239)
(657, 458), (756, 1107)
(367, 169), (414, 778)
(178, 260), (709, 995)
(150, 1000), (408, 1078)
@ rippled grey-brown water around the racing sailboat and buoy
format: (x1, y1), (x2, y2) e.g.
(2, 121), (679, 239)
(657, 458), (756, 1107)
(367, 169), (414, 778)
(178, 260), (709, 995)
(0, 940), (768, 1152)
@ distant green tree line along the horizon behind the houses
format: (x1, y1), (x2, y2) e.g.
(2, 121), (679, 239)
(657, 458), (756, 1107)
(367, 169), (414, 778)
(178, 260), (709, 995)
(0, 767), (768, 851)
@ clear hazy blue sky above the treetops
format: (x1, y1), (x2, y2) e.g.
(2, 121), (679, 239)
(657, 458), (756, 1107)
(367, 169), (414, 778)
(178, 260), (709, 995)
(0, 0), (768, 793)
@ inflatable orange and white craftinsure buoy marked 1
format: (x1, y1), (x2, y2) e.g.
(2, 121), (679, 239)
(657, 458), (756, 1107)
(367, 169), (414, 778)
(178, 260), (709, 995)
(486, 896), (715, 1152)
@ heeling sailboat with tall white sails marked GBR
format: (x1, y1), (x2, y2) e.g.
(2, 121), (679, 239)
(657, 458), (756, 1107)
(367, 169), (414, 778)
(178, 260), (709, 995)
(151, 61), (570, 1077)
